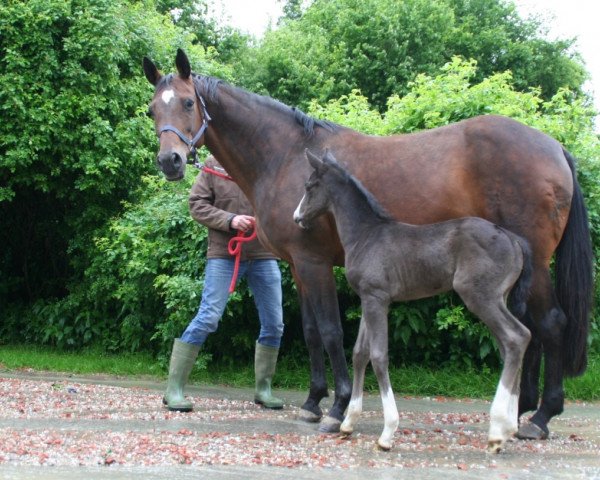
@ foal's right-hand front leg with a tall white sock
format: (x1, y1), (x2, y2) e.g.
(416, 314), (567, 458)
(362, 297), (400, 450)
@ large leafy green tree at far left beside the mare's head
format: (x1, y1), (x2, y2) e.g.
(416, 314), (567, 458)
(0, 0), (227, 307)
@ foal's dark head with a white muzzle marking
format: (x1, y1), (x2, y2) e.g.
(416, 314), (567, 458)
(294, 149), (336, 228)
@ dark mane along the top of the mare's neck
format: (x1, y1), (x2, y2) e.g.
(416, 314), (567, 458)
(192, 73), (342, 137)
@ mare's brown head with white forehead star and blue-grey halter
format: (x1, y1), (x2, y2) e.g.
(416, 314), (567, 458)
(143, 49), (210, 180)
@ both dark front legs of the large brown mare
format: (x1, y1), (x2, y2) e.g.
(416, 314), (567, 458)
(294, 259), (351, 433)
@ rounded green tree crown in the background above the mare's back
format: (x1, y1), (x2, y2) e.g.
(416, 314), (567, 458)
(245, 0), (585, 111)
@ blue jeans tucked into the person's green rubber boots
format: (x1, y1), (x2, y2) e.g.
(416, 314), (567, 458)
(180, 258), (283, 348)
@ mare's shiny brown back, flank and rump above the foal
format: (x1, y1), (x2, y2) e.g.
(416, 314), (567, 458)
(333, 115), (573, 260)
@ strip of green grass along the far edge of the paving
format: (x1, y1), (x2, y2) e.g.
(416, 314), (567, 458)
(0, 346), (600, 401)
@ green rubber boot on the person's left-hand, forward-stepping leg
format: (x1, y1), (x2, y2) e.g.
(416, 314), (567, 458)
(163, 338), (200, 412)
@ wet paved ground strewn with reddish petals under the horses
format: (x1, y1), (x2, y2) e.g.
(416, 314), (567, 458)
(0, 372), (600, 480)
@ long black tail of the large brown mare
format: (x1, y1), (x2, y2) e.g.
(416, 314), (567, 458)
(554, 148), (594, 377)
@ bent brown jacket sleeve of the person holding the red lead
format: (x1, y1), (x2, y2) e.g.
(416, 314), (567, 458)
(189, 171), (235, 232)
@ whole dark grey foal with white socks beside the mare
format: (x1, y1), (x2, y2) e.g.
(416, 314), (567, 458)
(294, 150), (531, 452)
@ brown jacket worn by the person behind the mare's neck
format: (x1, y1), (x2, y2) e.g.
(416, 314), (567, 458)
(189, 156), (277, 261)
